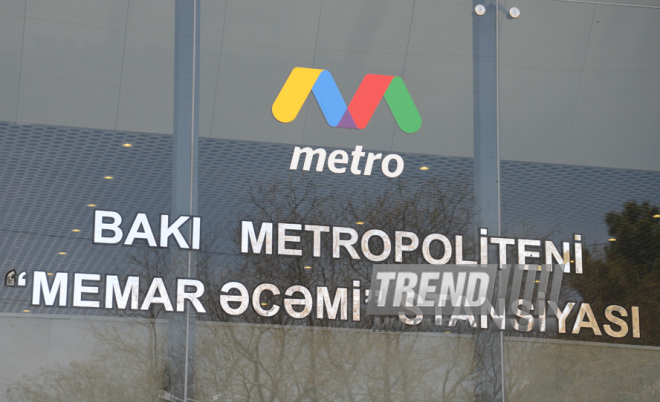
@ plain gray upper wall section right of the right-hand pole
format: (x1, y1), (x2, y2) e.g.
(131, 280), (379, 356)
(500, 0), (660, 170)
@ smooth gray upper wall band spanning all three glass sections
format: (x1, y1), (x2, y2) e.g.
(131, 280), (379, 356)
(0, 0), (660, 170)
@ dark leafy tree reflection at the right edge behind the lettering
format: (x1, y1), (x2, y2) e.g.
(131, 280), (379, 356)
(570, 201), (660, 345)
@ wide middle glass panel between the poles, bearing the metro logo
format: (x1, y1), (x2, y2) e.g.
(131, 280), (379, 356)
(194, 0), (499, 400)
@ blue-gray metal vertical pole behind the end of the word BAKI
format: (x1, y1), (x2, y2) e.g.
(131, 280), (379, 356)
(167, 0), (200, 401)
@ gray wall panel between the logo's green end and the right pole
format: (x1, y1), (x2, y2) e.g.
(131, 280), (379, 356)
(392, 0), (474, 157)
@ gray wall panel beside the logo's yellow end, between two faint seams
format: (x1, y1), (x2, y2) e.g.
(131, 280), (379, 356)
(206, 0), (321, 143)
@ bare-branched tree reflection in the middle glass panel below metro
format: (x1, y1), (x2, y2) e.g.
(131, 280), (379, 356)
(189, 177), (475, 400)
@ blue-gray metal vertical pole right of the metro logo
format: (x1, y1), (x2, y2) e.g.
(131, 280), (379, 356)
(472, 0), (504, 401)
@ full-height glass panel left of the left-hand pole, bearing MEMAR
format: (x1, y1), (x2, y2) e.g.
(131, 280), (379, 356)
(0, 0), (190, 401)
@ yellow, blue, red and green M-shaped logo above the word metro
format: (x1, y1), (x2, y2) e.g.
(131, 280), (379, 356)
(273, 67), (422, 133)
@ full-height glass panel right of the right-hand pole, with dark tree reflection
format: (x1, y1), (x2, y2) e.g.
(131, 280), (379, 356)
(499, 1), (660, 401)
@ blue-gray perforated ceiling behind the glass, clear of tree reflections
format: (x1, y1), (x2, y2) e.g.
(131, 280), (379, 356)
(0, 119), (660, 313)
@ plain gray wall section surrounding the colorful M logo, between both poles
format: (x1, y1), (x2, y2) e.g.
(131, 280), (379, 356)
(201, 0), (472, 156)
